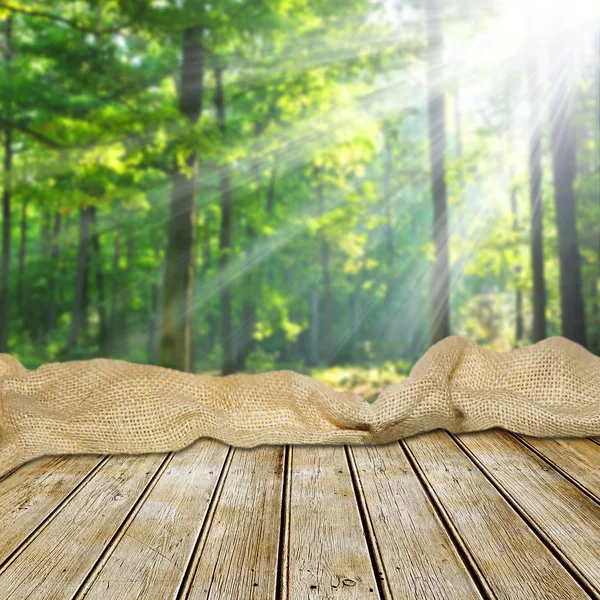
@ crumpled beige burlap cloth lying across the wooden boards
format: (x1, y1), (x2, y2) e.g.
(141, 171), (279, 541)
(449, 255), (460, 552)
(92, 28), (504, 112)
(0, 337), (600, 475)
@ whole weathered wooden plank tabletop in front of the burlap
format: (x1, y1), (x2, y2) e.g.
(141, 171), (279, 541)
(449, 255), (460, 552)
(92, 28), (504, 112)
(0, 430), (600, 600)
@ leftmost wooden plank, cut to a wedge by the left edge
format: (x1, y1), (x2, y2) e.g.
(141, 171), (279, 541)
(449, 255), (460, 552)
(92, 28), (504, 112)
(0, 456), (102, 571)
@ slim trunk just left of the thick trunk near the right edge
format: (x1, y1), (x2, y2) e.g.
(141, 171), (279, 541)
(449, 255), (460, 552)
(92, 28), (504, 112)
(526, 32), (546, 342)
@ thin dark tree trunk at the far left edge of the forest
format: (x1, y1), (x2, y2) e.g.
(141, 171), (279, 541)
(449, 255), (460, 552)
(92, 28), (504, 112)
(0, 16), (13, 352)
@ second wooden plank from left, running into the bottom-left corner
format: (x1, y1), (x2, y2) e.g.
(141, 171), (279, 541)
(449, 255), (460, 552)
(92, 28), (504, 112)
(0, 454), (165, 600)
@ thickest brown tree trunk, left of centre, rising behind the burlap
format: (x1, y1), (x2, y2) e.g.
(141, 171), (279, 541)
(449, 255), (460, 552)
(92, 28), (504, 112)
(159, 25), (204, 371)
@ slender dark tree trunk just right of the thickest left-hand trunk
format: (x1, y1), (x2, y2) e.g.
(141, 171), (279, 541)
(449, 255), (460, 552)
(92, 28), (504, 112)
(215, 66), (236, 375)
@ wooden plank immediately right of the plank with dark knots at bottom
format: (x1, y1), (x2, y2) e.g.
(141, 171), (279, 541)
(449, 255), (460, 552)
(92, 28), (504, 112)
(350, 443), (482, 600)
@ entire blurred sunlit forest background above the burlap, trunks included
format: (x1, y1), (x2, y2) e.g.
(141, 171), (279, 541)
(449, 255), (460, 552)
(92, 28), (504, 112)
(0, 0), (600, 382)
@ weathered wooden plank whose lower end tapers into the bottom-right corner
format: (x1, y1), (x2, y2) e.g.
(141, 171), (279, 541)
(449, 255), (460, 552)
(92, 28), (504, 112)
(457, 430), (600, 595)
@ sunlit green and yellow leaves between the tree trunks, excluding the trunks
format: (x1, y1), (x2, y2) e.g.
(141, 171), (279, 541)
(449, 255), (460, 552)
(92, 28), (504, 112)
(0, 0), (600, 370)
